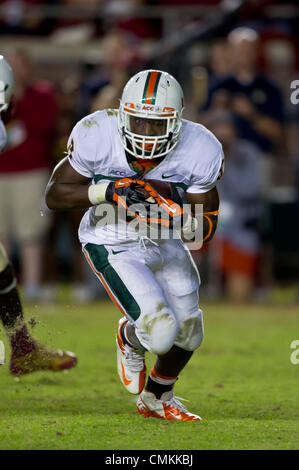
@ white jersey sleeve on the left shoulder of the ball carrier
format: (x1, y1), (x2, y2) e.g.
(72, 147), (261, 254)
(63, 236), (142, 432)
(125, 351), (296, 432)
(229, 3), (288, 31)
(67, 122), (94, 178)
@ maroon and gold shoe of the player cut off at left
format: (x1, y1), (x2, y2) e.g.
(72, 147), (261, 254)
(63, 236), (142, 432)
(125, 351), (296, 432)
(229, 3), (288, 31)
(9, 341), (77, 375)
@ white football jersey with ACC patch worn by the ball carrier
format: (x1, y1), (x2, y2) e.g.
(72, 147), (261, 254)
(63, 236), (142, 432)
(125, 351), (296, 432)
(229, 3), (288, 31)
(68, 109), (224, 245)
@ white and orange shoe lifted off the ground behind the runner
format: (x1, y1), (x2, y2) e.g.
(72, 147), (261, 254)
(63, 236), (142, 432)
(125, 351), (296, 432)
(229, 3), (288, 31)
(116, 317), (146, 394)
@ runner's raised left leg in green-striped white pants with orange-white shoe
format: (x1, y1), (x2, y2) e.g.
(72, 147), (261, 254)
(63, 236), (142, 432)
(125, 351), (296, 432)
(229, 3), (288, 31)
(83, 244), (177, 393)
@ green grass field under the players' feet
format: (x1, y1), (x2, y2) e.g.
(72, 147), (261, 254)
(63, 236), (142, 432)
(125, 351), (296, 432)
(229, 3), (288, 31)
(0, 301), (299, 450)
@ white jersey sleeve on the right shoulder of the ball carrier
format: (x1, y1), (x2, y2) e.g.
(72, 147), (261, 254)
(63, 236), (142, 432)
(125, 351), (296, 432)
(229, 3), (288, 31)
(187, 129), (224, 193)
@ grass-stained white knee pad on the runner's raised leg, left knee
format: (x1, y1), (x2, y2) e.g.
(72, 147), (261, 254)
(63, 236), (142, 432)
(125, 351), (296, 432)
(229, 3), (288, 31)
(135, 309), (179, 355)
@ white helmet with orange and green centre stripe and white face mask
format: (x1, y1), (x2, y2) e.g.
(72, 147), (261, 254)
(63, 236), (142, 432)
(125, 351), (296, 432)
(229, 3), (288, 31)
(118, 70), (184, 159)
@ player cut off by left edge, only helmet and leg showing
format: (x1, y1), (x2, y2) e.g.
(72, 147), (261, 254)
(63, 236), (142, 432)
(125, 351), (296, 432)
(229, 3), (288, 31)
(0, 55), (77, 375)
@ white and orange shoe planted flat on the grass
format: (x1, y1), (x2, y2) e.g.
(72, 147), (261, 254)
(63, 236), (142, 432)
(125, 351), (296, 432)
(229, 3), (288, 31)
(137, 390), (201, 421)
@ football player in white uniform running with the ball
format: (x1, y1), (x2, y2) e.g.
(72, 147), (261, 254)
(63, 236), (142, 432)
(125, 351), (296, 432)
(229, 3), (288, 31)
(46, 70), (223, 421)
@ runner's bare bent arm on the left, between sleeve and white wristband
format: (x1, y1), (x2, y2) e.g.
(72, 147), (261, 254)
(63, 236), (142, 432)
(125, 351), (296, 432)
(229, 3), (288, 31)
(46, 157), (93, 210)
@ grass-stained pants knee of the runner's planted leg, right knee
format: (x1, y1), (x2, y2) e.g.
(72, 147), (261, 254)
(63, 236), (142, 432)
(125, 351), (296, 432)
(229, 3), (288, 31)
(175, 309), (204, 351)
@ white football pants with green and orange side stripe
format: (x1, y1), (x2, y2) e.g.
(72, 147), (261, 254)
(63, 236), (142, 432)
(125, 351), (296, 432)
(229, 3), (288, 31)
(83, 237), (203, 355)
